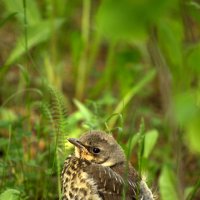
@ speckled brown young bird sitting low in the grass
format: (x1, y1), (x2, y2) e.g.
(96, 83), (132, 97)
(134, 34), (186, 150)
(61, 130), (154, 200)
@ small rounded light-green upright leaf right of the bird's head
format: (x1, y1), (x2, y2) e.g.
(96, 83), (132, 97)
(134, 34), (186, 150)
(143, 130), (158, 158)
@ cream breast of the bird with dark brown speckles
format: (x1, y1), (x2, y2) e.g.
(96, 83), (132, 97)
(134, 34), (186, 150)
(61, 156), (102, 200)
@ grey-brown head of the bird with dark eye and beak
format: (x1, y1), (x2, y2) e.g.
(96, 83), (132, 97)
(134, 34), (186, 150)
(68, 131), (125, 167)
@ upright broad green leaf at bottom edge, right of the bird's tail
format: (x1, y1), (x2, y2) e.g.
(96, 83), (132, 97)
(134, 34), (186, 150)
(159, 166), (179, 200)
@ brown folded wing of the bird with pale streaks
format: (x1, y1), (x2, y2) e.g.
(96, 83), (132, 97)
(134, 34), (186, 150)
(85, 164), (138, 200)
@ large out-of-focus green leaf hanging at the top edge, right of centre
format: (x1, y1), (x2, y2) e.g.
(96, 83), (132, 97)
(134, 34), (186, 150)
(97, 0), (176, 39)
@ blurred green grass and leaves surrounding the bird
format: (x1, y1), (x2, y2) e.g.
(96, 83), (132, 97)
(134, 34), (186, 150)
(0, 0), (200, 200)
